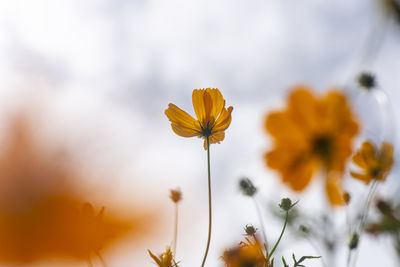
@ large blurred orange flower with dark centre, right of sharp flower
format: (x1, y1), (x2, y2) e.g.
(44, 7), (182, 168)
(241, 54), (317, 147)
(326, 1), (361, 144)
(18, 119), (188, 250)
(265, 86), (358, 205)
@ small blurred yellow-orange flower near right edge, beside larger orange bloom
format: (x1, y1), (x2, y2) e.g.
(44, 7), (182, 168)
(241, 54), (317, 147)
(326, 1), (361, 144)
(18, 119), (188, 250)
(350, 142), (393, 184)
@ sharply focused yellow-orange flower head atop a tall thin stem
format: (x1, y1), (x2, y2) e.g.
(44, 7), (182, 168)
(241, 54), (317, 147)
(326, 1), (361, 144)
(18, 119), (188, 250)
(165, 88), (233, 149)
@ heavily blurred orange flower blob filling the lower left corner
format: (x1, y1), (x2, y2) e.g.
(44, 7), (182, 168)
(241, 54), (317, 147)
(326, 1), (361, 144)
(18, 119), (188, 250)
(0, 117), (152, 263)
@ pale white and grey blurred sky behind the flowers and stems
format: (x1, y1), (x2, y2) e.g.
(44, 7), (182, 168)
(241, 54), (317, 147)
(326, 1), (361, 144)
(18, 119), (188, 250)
(0, 0), (400, 266)
